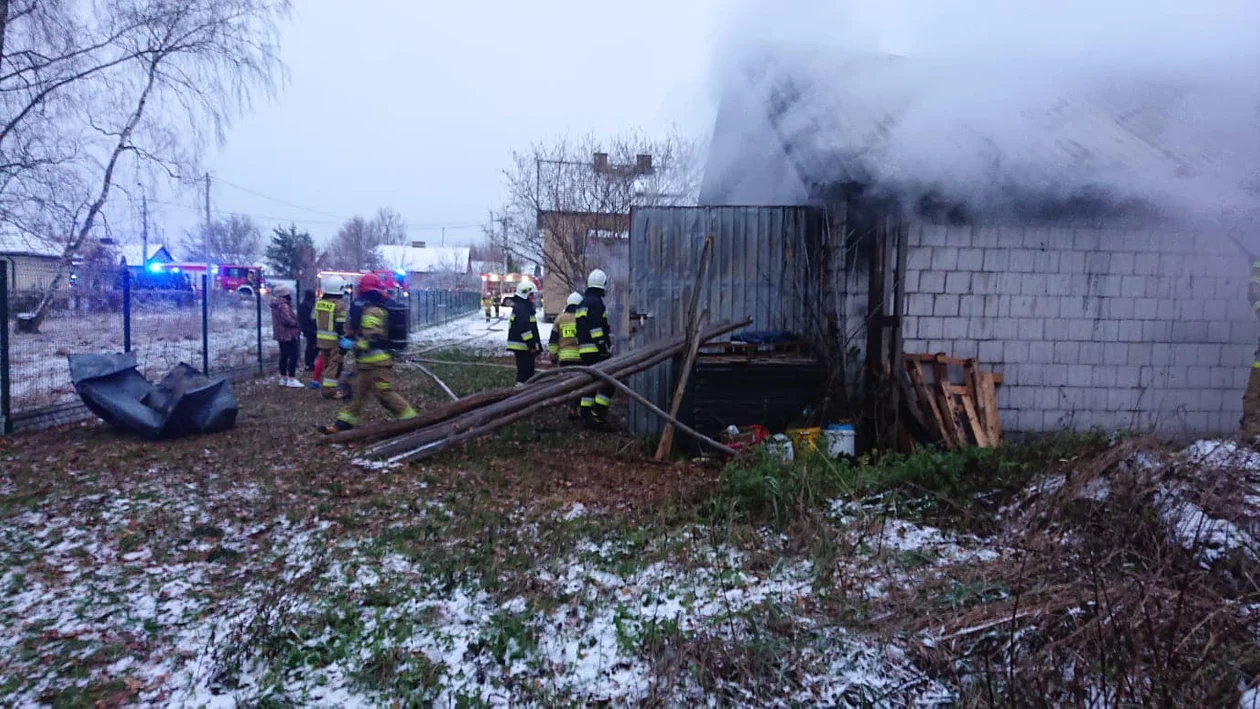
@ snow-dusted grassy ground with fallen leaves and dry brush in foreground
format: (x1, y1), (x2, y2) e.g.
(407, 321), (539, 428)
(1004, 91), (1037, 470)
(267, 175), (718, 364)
(0, 353), (1260, 706)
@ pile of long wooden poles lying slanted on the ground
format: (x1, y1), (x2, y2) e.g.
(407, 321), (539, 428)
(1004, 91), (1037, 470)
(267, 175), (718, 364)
(323, 320), (750, 463)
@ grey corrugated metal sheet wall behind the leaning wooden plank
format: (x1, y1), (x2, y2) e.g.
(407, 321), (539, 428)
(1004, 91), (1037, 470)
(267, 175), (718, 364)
(629, 207), (824, 434)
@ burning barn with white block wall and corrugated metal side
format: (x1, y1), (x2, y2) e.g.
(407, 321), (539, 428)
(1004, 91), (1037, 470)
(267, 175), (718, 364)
(630, 51), (1260, 443)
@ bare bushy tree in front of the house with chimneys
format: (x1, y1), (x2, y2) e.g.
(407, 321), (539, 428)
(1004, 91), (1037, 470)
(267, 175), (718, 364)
(486, 132), (701, 294)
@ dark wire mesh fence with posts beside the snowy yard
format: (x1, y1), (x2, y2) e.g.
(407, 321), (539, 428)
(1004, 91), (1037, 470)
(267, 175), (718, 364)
(0, 259), (480, 433)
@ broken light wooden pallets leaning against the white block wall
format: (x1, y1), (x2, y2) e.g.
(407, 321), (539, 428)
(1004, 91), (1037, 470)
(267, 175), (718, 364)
(903, 354), (1002, 448)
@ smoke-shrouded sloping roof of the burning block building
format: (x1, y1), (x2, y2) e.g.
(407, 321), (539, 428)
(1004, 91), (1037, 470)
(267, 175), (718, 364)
(701, 48), (1260, 222)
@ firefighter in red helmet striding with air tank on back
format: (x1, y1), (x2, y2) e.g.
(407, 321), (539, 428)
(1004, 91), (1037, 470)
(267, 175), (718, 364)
(320, 273), (416, 433)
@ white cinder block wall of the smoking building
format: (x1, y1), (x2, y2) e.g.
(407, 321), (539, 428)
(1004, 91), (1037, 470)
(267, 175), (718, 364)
(902, 224), (1260, 434)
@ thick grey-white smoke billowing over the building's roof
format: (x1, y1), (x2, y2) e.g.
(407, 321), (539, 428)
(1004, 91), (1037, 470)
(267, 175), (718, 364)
(706, 0), (1260, 222)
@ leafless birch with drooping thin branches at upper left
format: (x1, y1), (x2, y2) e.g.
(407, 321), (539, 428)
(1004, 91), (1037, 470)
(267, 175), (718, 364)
(0, 0), (289, 326)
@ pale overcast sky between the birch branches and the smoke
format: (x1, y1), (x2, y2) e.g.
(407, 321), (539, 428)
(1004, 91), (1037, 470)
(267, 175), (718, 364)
(152, 0), (719, 244)
